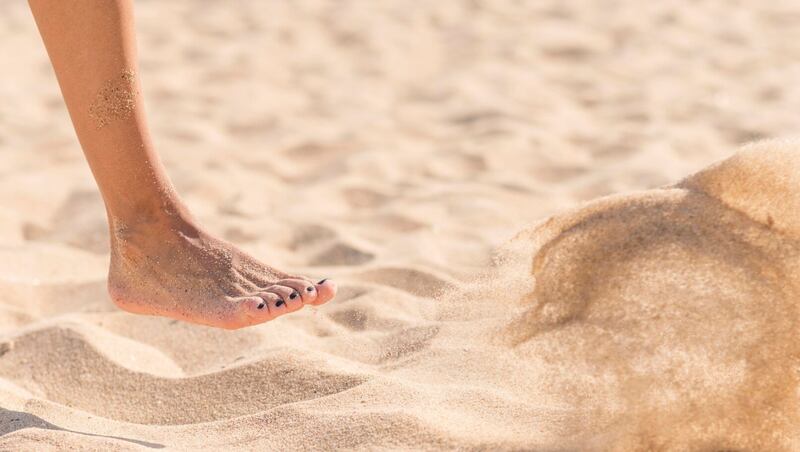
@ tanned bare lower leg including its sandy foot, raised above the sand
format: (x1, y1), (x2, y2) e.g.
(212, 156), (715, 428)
(29, 0), (335, 327)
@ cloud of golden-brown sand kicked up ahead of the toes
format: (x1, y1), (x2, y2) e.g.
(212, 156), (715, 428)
(507, 141), (800, 450)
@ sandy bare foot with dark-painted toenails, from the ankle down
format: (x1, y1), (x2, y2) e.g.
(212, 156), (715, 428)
(108, 212), (336, 329)
